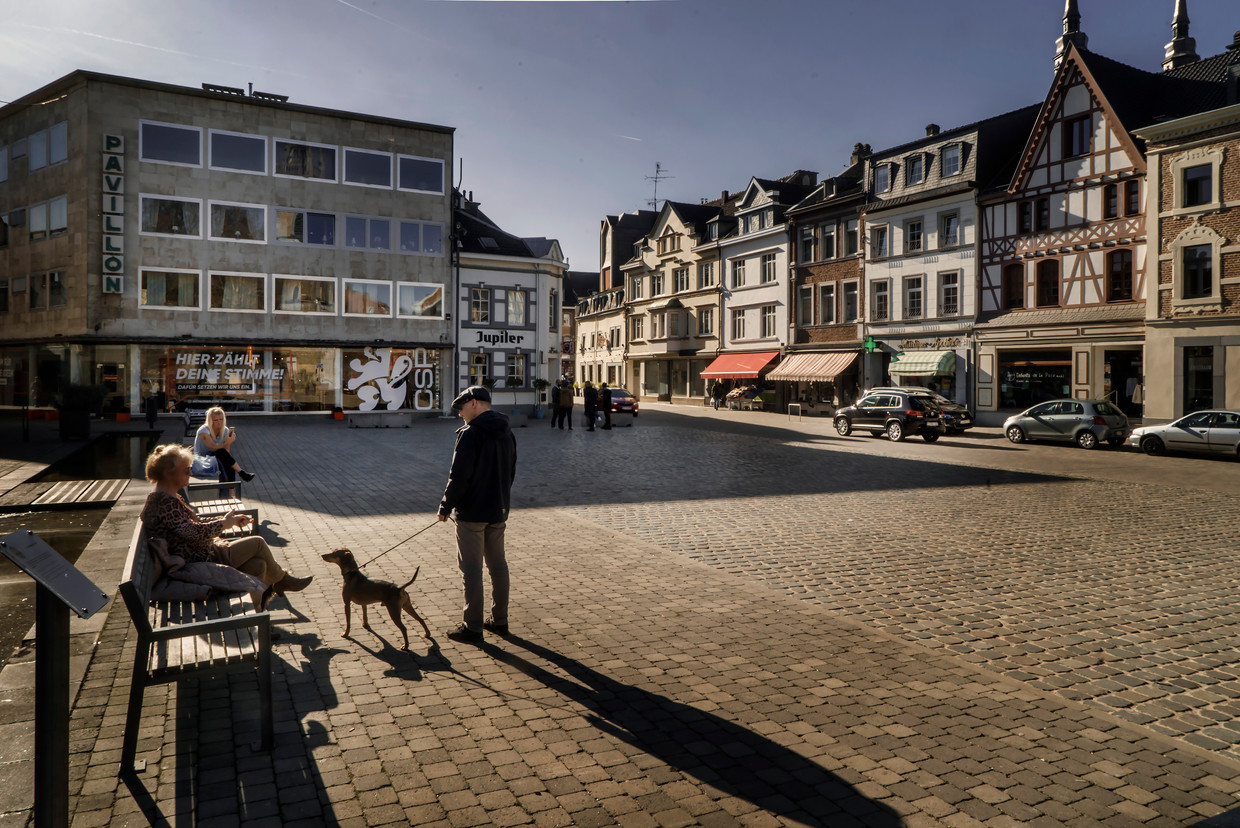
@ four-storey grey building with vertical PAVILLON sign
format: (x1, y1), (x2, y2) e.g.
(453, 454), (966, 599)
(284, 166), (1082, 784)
(0, 72), (453, 413)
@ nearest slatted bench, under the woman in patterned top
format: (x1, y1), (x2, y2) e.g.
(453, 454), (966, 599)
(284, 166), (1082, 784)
(120, 521), (273, 772)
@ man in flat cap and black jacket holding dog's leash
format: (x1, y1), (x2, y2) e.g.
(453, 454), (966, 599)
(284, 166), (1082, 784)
(439, 385), (517, 641)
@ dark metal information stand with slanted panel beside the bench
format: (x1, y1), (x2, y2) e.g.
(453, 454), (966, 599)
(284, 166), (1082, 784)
(0, 529), (108, 828)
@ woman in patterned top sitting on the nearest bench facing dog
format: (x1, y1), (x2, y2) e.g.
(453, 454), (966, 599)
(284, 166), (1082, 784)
(141, 444), (314, 609)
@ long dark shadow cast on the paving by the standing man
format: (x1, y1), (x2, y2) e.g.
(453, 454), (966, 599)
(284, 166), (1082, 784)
(480, 636), (903, 828)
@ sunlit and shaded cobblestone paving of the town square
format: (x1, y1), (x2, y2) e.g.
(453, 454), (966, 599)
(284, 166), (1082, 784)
(58, 414), (1240, 828)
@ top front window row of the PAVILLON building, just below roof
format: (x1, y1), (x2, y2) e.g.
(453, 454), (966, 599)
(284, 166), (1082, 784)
(138, 120), (444, 195)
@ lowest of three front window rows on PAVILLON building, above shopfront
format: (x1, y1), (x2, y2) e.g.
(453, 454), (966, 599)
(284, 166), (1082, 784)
(138, 268), (444, 319)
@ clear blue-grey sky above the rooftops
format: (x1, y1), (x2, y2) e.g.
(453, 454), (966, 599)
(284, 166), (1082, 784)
(0, 0), (1240, 270)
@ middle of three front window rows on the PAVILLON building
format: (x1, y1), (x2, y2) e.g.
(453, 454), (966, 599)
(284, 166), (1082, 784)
(139, 195), (444, 255)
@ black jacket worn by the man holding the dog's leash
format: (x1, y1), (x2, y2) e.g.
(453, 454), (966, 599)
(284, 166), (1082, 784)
(439, 410), (517, 523)
